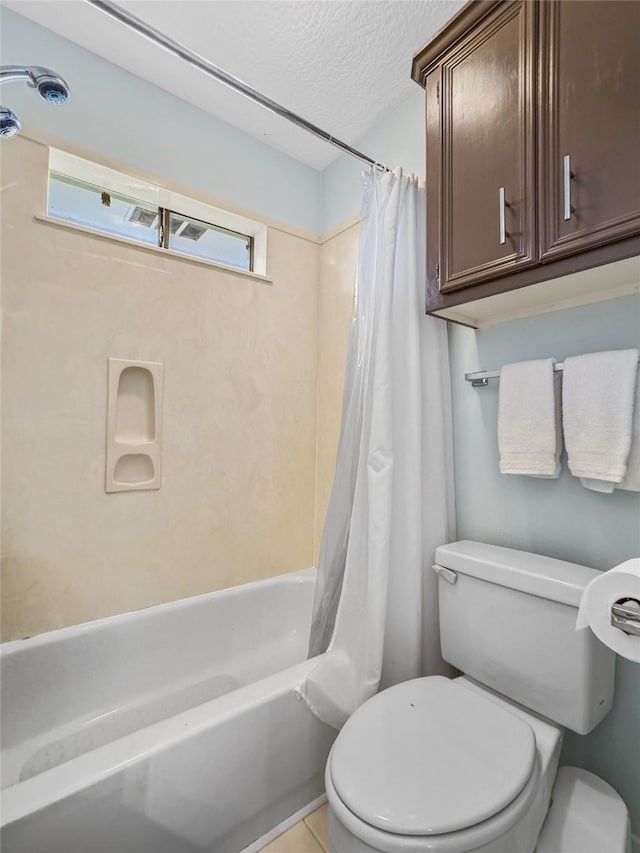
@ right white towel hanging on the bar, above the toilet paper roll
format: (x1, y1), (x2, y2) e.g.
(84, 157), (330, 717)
(562, 349), (638, 492)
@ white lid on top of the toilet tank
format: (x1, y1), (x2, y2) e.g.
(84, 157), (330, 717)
(434, 540), (600, 607)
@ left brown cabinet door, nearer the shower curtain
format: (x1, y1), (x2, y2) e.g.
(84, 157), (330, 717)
(440, 0), (537, 292)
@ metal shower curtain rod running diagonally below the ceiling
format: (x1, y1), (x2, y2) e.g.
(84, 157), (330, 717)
(86, 0), (389, 172)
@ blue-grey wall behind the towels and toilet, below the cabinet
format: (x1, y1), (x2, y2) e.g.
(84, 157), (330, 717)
(450, 296), (640, 833)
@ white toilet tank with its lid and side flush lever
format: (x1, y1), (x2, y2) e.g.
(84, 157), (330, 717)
(434, 541), (615, 734)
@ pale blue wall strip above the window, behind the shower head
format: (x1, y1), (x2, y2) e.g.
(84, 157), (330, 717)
(0, 8), (322, 233)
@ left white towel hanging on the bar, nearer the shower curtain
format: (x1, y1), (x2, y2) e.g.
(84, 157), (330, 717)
(498, 358), (562, 477)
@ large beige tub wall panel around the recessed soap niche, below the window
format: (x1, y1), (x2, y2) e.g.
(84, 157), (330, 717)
(1, 137), (321, 640)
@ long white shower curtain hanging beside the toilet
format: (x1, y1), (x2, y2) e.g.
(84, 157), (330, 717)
(298, 170), (453, 728)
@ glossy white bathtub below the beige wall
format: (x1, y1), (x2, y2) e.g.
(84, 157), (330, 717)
(0, 569), (335, 853)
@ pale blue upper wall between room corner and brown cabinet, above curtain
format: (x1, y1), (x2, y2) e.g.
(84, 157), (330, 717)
(322, 91), (425, 232)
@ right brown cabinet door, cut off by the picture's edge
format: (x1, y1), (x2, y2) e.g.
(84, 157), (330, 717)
(540, 0), (640, 261)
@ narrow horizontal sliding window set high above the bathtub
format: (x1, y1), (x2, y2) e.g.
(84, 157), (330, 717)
(47, 149), (267, 275)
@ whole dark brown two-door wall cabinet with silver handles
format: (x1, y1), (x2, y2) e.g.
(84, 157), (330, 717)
(413, 0), (640, 326)
